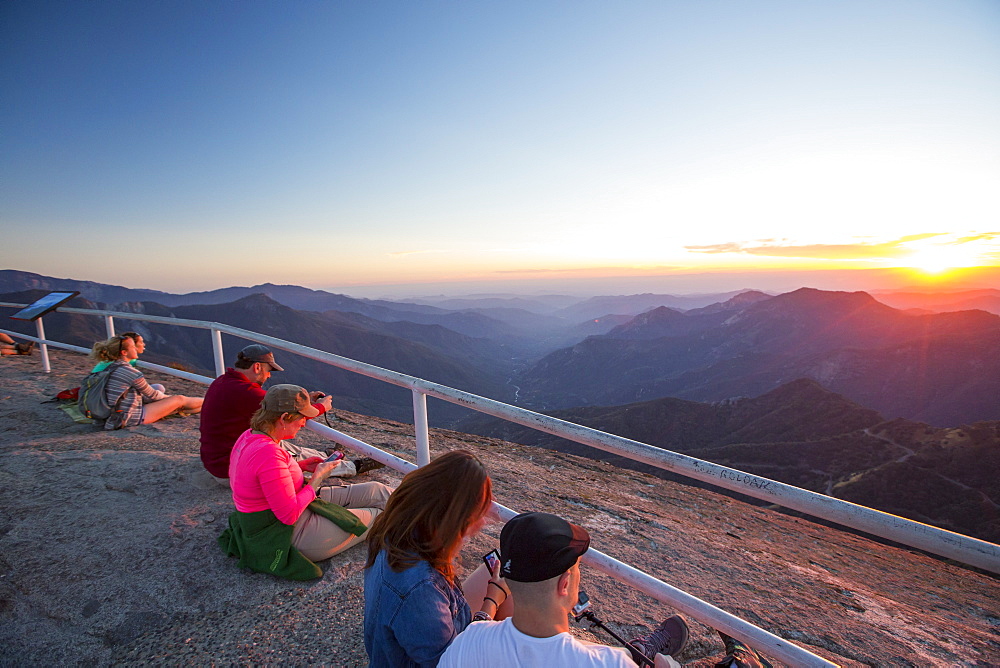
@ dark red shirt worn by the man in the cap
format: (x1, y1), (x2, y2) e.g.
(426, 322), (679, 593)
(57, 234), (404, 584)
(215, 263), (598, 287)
(201, 368), (326, 478)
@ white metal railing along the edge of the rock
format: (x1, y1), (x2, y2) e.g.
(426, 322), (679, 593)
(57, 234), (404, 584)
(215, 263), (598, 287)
(7, 302), (1000, 666)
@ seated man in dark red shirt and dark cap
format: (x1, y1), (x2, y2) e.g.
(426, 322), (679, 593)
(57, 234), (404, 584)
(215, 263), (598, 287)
(199, 343), (383, 487)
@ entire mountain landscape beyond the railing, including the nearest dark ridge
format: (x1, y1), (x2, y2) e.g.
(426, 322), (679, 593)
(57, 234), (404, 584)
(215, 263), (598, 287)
(7, 271), (1000, 541)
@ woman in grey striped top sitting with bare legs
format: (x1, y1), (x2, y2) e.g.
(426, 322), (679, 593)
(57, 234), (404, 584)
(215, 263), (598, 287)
(90, 336), (201, 429)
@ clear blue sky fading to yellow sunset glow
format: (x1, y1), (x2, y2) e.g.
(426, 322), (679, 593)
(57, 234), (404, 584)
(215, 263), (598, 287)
(0, 0), (1000, 296)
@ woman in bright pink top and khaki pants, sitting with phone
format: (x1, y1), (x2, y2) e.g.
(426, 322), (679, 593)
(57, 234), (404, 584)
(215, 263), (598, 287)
(219, 385), (391, 580)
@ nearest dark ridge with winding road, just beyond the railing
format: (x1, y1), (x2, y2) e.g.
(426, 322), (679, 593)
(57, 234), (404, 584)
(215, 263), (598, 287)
(458, 379), (1000, 542)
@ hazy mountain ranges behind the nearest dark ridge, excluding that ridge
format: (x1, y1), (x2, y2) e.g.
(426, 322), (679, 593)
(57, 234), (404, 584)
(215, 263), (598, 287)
(0, 270), (1000, 426)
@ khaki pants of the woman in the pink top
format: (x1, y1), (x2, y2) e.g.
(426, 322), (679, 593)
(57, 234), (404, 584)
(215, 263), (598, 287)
(292, 482), (392, 561)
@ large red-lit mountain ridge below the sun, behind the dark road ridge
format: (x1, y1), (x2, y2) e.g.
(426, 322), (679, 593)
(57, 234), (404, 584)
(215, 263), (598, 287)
(519, 288), (1000, 426)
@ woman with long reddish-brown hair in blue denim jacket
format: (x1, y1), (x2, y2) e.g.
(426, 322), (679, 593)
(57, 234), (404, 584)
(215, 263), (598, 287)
(365, 450), (513, 668)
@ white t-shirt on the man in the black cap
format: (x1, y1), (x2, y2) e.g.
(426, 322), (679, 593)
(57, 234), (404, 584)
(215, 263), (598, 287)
(438, 618), (636, 668)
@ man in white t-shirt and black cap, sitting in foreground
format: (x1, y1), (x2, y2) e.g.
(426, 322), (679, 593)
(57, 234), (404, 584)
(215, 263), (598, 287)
(438, 513), (688, 668)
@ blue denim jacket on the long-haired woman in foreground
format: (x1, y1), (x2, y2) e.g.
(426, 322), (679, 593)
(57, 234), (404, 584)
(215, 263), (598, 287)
(365, 550), (472, 668)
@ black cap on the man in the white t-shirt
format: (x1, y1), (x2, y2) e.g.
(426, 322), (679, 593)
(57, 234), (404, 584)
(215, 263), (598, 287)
(500, 513), (590, 582)
